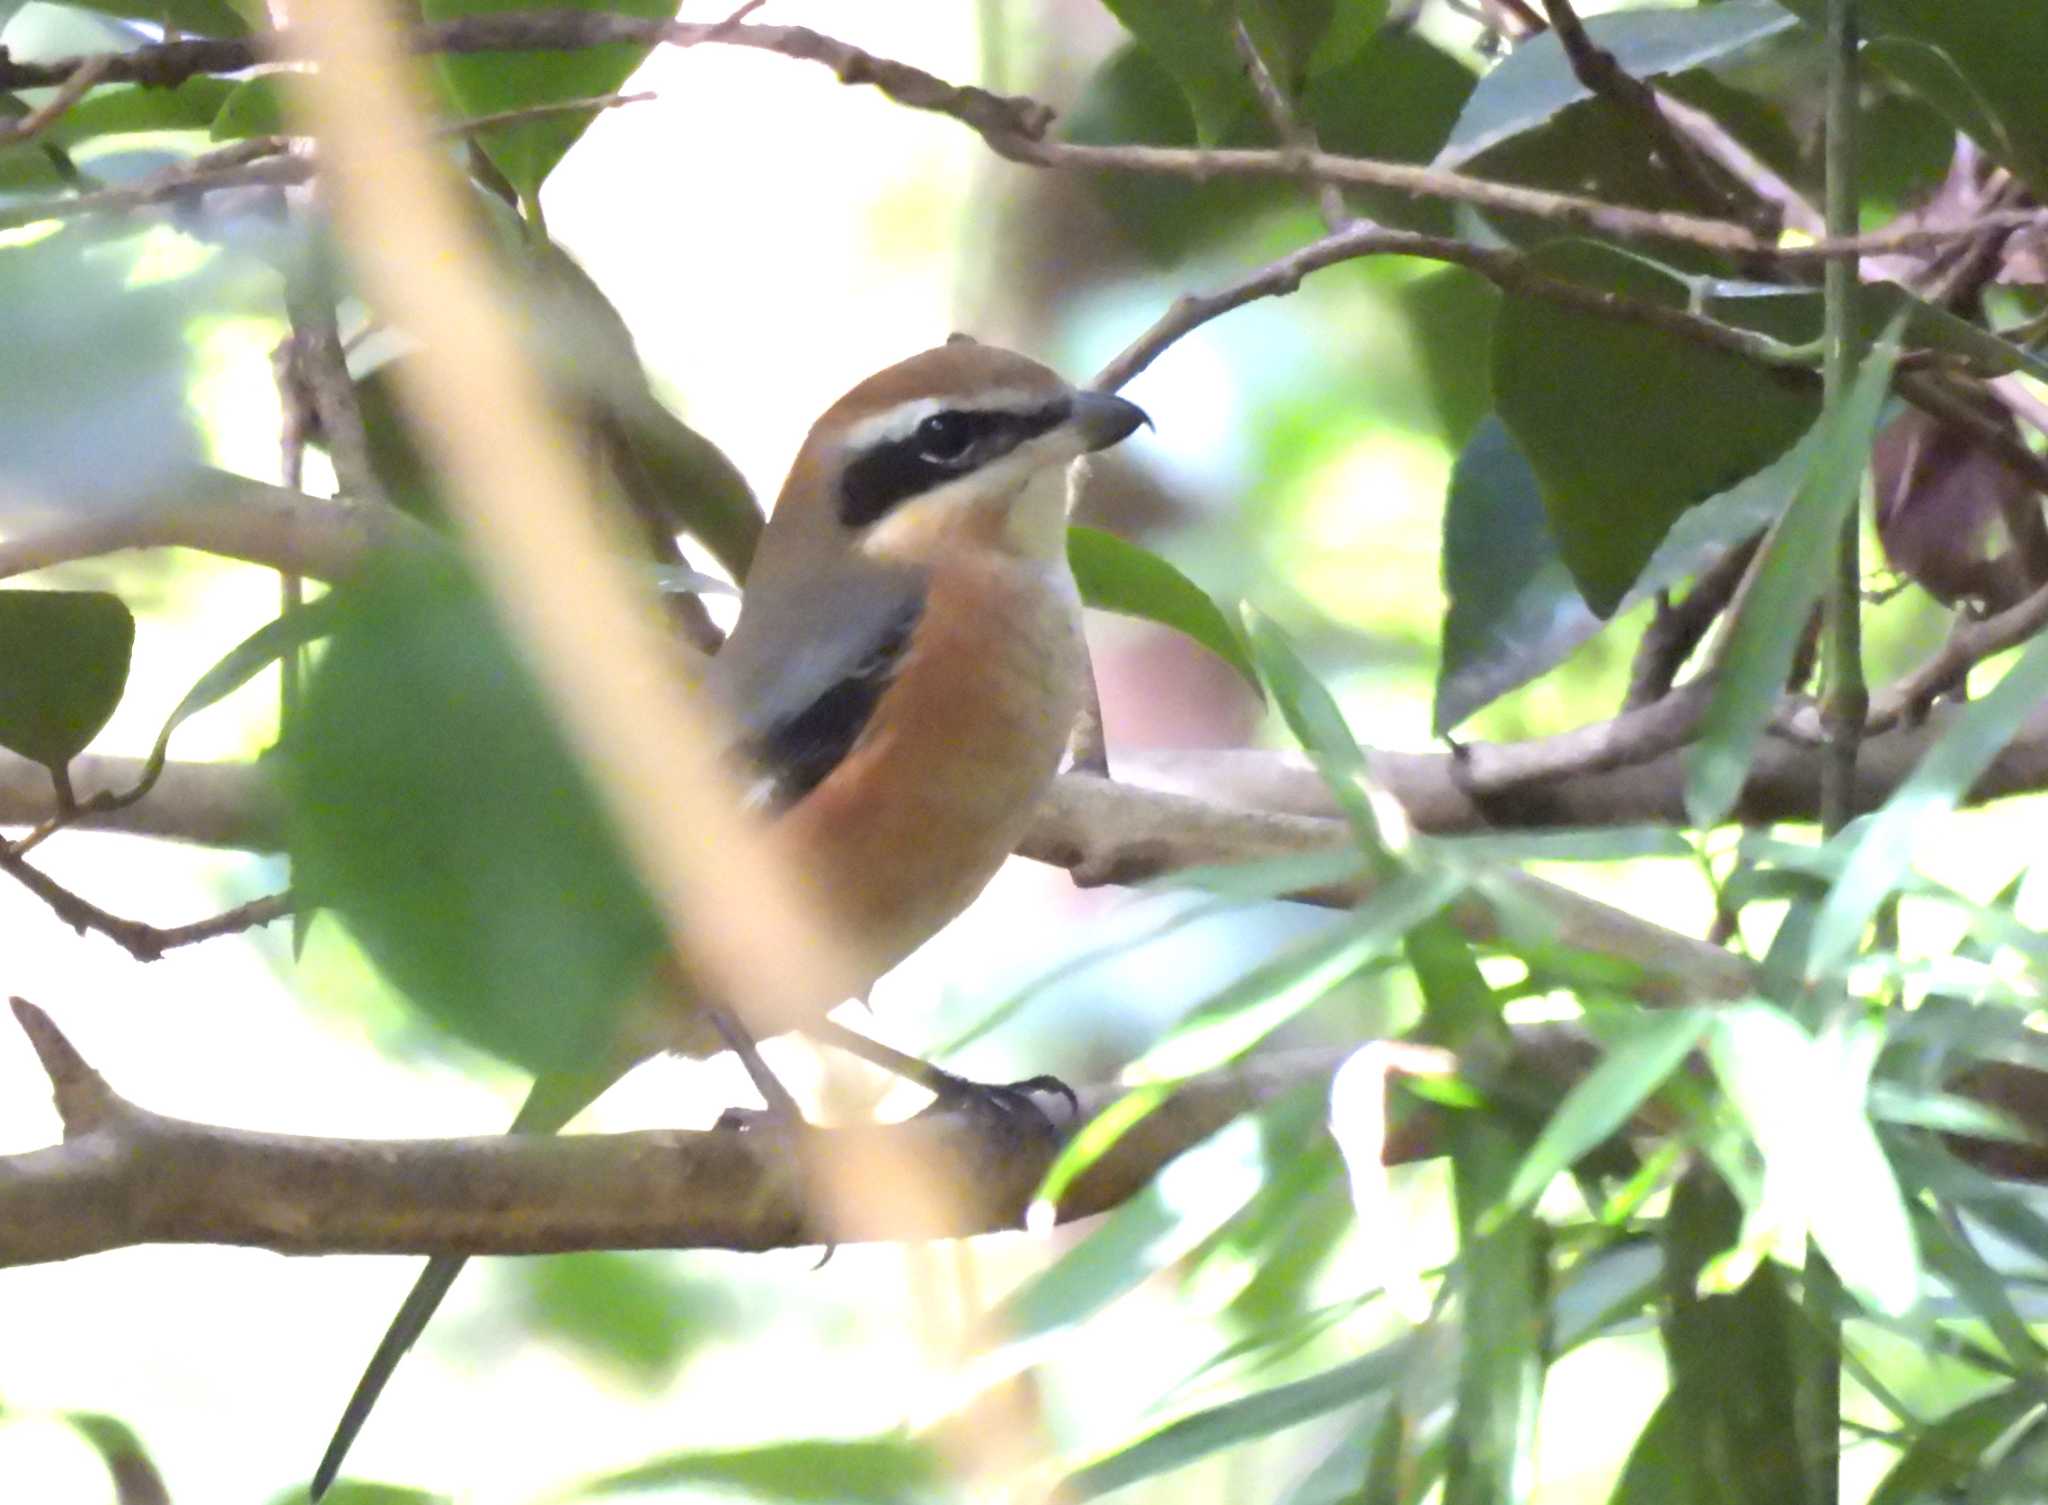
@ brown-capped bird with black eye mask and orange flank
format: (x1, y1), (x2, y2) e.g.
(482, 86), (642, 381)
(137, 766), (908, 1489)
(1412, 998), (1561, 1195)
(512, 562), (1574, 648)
(309, 336), (1151, 1501)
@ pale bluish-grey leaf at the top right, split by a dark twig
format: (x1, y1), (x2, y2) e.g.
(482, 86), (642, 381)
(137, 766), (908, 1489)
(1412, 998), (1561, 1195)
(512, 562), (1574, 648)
(1442, 0), (1798, 166)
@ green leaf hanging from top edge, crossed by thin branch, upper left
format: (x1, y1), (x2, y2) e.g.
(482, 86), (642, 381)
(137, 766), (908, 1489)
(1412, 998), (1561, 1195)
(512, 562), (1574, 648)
(420, 0), (676, 201)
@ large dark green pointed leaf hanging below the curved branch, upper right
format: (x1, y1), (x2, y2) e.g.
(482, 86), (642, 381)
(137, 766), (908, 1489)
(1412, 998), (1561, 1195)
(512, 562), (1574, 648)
(1493, 242), (1819, 616)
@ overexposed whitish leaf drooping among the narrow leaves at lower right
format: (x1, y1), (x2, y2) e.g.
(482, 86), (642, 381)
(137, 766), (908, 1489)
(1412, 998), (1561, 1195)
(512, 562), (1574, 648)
(1706, 1003), (1919, 1317)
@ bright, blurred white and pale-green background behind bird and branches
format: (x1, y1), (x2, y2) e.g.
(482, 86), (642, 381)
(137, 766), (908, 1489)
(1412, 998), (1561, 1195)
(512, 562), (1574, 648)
(0, 0), (2038, 1505)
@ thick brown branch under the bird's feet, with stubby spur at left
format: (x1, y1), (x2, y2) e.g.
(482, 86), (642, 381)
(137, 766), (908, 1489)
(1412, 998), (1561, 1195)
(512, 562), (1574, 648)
(0, 999), (1368, 1265)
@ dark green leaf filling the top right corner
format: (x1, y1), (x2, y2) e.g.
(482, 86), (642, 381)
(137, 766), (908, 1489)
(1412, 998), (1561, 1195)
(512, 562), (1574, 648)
(1784, 0), (2048, 192)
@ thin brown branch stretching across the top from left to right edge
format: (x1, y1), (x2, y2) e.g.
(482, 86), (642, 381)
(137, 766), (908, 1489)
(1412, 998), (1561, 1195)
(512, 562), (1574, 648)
(0, 10), (2040, 262)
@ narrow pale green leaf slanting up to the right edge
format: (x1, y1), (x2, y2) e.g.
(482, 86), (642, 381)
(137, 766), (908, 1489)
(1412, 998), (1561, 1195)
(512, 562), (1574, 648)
(1808, 637), (2048, 977)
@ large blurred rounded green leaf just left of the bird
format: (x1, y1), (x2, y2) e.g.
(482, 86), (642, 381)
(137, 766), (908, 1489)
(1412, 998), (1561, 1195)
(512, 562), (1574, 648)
(276, 549), (666, 1073)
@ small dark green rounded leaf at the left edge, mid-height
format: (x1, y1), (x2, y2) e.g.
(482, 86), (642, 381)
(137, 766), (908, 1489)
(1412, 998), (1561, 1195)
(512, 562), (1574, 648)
(0, 590), (135, 770)
